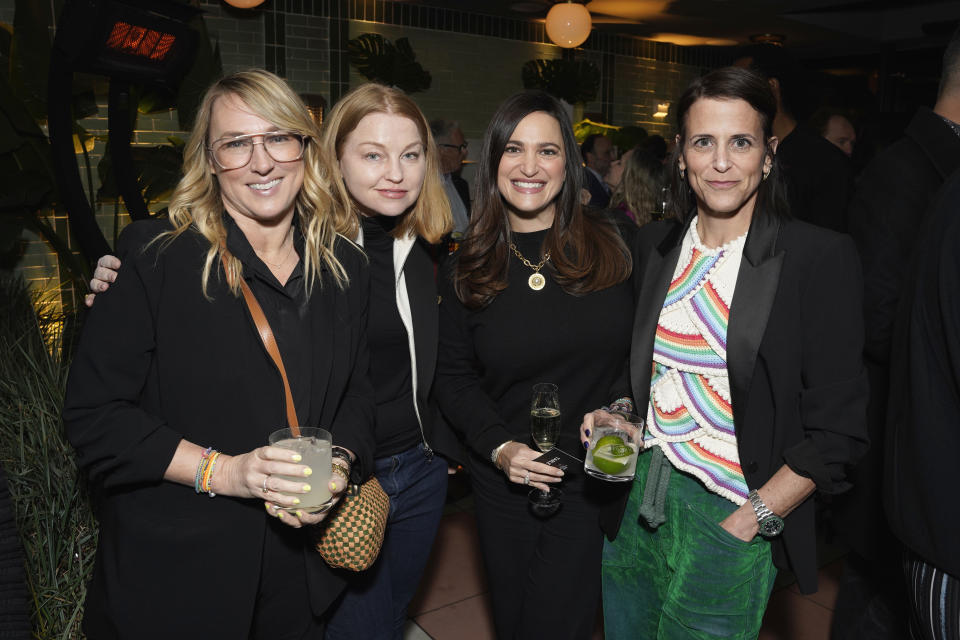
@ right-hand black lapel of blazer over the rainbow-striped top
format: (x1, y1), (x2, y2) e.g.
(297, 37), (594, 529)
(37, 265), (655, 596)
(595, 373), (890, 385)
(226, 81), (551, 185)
(727, 216), (784, 439)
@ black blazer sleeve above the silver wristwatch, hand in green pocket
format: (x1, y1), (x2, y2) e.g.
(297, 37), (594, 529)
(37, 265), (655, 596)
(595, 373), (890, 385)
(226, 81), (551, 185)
(784, 235), (868, 493)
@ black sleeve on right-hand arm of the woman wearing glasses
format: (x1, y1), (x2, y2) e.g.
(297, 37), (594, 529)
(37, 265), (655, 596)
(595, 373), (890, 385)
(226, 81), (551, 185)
(327, 241), (376, 483)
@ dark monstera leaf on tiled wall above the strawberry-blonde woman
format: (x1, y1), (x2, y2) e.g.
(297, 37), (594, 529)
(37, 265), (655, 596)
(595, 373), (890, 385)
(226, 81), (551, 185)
(347, 33), (432, 93)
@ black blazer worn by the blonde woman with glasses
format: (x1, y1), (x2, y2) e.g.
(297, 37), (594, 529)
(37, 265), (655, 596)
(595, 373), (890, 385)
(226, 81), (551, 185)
(64, 221), (374, 638)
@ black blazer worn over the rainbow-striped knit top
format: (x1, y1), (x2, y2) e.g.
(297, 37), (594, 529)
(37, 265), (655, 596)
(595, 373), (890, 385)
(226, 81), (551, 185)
(601, 216), (867, 593)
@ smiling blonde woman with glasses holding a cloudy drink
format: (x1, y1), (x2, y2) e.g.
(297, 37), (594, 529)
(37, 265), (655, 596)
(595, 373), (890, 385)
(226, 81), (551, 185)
(64, 71), (373, 640)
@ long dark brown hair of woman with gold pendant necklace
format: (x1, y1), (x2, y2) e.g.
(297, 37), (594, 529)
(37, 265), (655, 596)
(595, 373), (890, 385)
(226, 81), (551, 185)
(454, 91), (632, 309)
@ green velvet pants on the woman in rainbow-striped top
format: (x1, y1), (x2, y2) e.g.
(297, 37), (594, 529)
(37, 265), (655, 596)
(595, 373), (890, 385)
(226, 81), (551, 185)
(603, 452), (777, 640)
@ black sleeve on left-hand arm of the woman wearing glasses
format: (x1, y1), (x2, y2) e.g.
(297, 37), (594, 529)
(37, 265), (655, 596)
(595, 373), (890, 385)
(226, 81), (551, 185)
(63, 222), (182, 488)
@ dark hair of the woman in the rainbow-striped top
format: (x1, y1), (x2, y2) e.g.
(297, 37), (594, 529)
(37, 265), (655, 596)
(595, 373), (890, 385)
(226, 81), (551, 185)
(668, 67), (790, 223)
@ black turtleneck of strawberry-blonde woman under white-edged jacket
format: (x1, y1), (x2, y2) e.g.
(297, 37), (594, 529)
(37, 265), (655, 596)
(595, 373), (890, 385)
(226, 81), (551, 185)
(363, 216), (421, 458)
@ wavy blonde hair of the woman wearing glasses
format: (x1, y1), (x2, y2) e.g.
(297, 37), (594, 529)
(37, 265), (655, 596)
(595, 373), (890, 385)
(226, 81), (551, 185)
(158, 69), (349, 298)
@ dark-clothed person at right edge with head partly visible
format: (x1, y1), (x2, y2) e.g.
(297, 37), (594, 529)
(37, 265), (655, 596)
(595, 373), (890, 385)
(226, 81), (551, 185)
(833, 32), (960, 640)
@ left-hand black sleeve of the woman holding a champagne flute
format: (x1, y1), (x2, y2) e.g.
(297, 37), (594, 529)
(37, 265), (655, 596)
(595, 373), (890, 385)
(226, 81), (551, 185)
(434, 256), (512, 458)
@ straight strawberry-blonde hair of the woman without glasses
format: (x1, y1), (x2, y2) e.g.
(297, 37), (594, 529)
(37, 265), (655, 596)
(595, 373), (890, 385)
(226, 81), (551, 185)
(320, 82), (453, 243)
